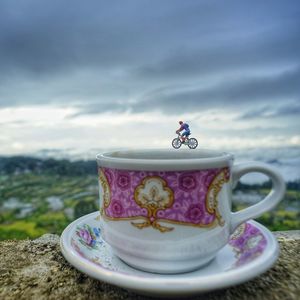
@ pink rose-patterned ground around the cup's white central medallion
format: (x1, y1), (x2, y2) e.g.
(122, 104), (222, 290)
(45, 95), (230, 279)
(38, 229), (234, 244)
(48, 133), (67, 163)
(99, 168), (230, 227)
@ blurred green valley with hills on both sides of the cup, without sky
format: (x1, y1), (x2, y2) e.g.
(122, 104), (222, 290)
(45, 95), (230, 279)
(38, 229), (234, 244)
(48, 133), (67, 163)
(0, 150), (300, 240)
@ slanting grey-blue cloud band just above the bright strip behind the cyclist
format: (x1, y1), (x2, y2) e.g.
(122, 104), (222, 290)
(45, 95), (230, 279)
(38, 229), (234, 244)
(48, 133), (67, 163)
(70, 67), (300, 119)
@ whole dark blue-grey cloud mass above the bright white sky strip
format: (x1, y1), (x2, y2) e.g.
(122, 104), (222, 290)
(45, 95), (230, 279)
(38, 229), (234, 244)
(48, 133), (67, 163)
(0, 0), (300, 114)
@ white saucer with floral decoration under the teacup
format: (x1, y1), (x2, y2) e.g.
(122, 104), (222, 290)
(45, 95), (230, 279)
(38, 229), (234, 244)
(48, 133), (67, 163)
(60, 212), (279, 297)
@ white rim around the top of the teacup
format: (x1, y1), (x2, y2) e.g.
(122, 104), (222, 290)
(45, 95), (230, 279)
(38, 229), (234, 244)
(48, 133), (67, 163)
(96, 148), (234, 171)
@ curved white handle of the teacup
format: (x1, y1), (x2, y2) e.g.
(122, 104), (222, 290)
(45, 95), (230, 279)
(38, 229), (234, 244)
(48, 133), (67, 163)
(230, 162), (286, 233)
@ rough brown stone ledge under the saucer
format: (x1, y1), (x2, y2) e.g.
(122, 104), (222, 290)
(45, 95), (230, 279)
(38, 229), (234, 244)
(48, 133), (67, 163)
(0, 231), (300, 300)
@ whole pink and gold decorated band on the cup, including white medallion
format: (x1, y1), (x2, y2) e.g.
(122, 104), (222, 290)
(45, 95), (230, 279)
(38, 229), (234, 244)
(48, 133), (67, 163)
(99, 168), (230, 232)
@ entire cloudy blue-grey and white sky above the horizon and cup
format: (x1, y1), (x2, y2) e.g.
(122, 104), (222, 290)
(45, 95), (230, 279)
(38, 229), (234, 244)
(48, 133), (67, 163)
(0, 0), (300, 155)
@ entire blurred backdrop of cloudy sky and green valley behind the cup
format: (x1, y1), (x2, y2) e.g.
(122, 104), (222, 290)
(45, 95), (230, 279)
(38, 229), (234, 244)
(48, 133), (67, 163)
(0, 0), (300, 239)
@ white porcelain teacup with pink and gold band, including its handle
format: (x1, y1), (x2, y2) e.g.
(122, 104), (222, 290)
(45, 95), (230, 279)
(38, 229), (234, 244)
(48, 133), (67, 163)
(97, 149), (285, 274)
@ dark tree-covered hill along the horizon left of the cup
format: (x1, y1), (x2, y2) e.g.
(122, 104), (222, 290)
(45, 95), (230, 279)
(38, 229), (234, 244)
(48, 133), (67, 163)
(0, 156), (97, 176)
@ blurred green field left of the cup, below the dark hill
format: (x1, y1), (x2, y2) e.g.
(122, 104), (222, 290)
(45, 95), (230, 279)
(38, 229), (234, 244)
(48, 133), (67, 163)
(0, 174), (98, 240)
